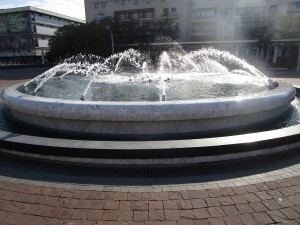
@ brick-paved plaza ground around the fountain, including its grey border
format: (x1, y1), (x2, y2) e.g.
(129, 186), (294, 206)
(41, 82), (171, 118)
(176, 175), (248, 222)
(0, 66), (300, 225)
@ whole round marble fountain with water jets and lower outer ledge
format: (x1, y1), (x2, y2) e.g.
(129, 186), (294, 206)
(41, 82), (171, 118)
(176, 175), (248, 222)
(1, 48), (296, 165)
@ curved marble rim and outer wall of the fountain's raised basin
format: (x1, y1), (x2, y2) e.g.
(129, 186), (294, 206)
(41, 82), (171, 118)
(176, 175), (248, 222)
(1, 82), (296, 137)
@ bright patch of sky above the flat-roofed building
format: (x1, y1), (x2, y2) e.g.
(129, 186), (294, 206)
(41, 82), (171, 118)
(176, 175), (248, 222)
(0, 0), (85, 20)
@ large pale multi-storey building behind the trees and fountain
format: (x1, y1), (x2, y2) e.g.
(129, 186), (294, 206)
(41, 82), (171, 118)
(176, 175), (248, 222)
(85, 0), (300, 68)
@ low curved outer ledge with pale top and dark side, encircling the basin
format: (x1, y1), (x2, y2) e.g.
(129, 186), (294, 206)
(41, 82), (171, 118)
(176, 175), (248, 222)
(0, 83), (300, 166)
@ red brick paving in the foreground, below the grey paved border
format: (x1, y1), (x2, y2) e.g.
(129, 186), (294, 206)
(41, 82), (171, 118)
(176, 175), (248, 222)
(0, 177), (300, 225)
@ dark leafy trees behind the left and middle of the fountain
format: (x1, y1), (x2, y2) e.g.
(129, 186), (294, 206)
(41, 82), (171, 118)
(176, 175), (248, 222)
(47, 17), (179, 61)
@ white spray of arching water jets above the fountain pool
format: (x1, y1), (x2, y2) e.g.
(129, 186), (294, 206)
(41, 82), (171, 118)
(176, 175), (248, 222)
(24, 45), (271, 100)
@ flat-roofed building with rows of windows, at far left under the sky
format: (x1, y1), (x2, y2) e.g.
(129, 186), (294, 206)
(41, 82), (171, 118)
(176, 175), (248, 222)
(0, 6), (85, 64)
